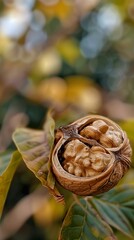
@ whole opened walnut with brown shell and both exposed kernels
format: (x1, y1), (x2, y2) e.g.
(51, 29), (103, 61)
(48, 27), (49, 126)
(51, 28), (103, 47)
(51, 115), (132, 196)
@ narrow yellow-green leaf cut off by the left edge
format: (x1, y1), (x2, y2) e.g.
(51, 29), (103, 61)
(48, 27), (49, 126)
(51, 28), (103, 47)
(0, 151), (21, 216)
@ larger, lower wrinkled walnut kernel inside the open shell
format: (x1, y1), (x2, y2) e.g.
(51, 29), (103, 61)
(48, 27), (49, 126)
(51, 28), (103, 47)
(62, 139), (111, 177)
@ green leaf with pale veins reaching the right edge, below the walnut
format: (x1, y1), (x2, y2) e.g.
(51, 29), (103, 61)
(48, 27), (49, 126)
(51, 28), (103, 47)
(89, 185), (134, 238)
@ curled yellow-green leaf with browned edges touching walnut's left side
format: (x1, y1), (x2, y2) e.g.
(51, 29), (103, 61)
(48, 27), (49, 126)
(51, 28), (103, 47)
(13, 128), (63, 201)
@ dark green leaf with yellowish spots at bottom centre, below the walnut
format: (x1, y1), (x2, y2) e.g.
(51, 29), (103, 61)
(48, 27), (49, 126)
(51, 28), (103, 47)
(59, 199), (116, 240)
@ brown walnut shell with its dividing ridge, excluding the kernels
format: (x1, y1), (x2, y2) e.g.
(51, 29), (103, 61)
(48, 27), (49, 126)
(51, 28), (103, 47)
(51, 115), (132, 196)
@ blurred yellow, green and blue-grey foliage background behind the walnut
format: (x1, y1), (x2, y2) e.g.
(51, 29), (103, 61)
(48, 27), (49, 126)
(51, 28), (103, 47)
(0, 0), (134, 240)
